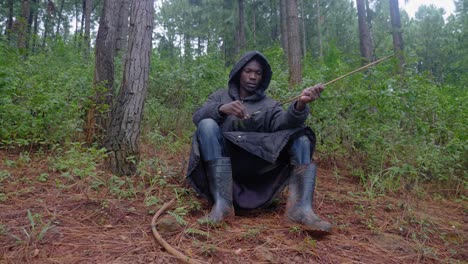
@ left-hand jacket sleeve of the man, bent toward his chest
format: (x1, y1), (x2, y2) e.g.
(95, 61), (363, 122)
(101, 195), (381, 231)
(192, 90), (226, 126)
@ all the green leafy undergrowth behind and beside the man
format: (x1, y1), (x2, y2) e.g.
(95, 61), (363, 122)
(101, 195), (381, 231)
(0, 43), (468, 197)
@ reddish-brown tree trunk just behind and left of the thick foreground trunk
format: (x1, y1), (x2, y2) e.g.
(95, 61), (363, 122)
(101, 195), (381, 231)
(86, 0), (119, 144)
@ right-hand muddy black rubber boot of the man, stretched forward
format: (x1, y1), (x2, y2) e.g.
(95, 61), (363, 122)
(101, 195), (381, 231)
(286, 164), (332, 235)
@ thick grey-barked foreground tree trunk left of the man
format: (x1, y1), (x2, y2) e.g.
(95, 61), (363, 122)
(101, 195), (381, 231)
(105, 0), (154, 175)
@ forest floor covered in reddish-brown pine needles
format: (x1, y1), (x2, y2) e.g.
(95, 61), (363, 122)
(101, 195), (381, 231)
(0, 146), (468, 263)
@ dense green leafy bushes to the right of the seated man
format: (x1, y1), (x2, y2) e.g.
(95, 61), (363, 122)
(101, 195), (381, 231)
(309, 56), (468, 191)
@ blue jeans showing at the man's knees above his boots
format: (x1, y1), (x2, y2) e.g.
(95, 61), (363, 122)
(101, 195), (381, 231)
(196, 118), (311, 165)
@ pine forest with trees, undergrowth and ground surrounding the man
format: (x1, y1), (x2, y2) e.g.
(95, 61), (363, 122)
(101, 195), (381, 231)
(0, 0), (468, 263)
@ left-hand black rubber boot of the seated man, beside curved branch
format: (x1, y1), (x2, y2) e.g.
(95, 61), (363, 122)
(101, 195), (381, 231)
(199, 158), (234, 223)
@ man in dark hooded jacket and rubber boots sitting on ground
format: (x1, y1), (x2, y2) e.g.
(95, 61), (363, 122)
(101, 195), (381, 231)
(187, 51), (331, 233)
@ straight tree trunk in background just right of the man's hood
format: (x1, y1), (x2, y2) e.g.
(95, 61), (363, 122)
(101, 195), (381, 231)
(286, 0), (302, 88)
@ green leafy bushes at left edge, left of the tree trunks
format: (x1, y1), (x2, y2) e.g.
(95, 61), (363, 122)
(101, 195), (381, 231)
(0, 43), (92, 147)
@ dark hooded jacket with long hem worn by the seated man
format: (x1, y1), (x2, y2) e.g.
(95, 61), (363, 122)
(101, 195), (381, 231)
(187, 51), (315, 209)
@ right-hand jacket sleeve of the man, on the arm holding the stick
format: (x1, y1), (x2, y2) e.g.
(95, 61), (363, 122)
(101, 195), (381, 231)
(270, 102), (310, 132)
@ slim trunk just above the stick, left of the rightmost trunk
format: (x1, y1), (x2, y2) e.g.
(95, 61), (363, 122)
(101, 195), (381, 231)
(356, 0), (374, 64)
